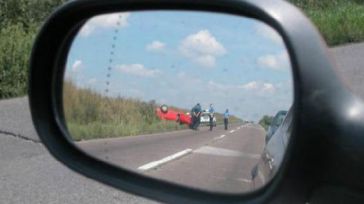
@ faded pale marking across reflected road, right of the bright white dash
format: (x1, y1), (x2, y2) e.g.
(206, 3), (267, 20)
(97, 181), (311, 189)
(193, 146), (260, 159)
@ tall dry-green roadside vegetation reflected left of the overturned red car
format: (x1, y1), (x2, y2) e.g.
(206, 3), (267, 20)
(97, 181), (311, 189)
(63, 81), (187, 140)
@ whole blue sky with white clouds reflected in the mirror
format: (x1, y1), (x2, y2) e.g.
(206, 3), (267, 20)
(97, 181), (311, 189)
(66, 11), (293, 121)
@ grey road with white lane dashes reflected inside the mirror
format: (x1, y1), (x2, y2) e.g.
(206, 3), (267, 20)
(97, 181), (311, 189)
(78, 124), (265, 193)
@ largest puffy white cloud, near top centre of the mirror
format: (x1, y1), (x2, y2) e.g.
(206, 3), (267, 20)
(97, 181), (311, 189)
(179, 30), (226, 67)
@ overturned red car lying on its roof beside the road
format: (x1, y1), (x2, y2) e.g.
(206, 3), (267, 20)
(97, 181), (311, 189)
(155, 105), (192, 126)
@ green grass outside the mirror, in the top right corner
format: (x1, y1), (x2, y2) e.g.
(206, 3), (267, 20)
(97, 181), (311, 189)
(290, 0), (364, 46)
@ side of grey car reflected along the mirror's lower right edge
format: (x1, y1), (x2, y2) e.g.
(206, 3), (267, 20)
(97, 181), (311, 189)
(251, 108), (293, 189)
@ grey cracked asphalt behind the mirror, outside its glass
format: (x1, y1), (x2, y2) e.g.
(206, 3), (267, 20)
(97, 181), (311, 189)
(0, 43), (364, 204)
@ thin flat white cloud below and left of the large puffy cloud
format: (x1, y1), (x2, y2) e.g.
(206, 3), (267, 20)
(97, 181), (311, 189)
(117, 64), (161, 77)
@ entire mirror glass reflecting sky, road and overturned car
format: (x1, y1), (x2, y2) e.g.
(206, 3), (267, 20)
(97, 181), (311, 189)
(63, 11), (293, 193)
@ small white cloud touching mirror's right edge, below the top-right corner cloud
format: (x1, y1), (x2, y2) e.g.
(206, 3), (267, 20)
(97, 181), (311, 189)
(257, 52), (290, 70)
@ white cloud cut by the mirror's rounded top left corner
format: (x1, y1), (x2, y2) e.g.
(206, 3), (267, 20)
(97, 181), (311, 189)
(80, 13), (130, 37)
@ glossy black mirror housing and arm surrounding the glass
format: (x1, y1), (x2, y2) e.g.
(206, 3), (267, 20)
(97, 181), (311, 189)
(29, 0), (364, 203)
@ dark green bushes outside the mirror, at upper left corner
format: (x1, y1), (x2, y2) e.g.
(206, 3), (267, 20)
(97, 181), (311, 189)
(0, 0), (65, 99)
